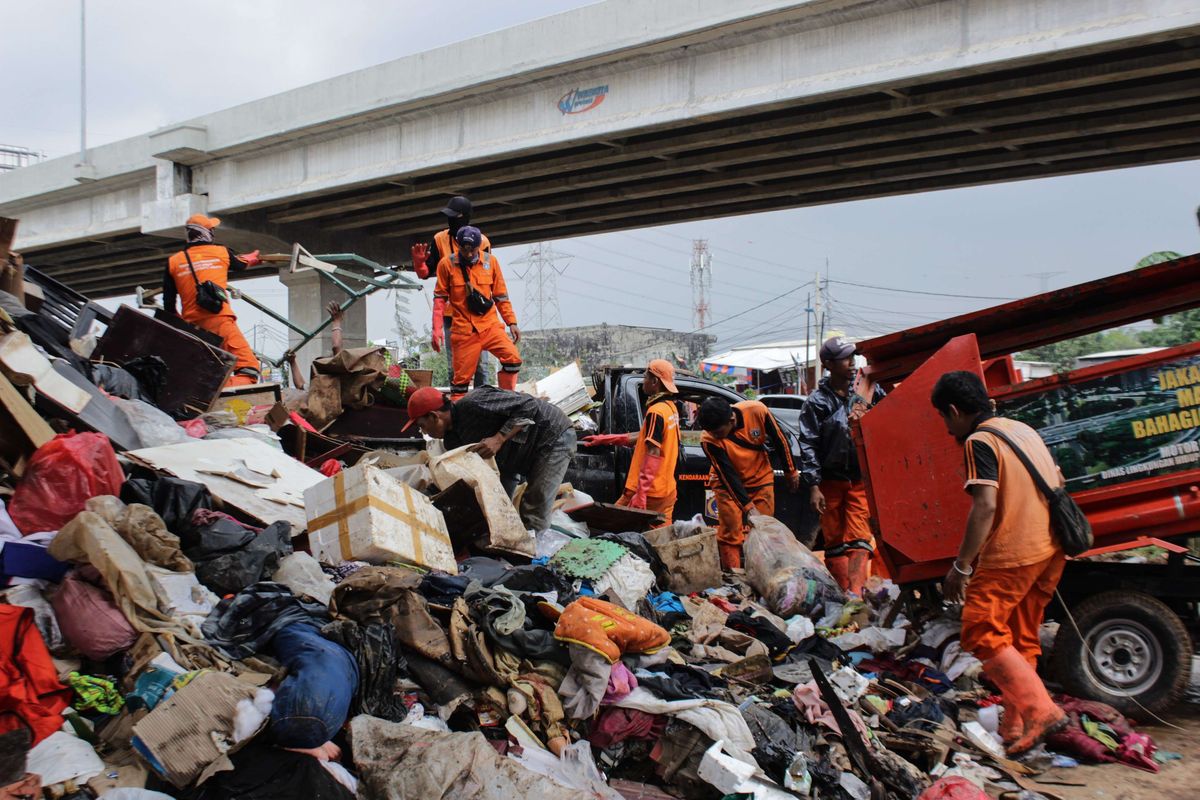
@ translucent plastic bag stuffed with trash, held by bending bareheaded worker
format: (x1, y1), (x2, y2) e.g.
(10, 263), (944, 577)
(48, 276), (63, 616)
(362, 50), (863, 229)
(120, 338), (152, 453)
(745, 515), (846, 619)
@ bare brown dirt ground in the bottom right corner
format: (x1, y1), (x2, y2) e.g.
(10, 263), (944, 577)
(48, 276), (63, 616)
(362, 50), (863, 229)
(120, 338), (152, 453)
(1036, 662), (1200, 800)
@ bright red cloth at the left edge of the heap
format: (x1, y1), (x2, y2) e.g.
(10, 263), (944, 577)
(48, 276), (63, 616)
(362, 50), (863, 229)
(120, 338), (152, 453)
(0, 606), (71, 745)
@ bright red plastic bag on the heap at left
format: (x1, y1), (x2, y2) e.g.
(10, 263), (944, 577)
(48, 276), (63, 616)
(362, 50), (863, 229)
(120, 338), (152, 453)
(8, 433), (125, 535)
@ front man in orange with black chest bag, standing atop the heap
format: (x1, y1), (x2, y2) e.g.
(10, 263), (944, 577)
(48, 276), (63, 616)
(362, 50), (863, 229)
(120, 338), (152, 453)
(433, 225), (521, 399)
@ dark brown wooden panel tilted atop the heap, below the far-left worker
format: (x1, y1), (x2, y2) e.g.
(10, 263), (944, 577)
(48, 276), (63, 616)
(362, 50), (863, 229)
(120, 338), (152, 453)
(92, 306), (236, 414)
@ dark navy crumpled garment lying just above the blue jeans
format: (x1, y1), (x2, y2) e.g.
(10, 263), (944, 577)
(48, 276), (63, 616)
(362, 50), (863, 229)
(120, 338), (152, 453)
(200, 581), (329, 658)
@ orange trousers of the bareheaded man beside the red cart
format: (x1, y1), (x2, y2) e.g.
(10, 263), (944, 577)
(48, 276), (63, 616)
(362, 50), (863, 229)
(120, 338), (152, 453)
(962, 553), (1067, 666)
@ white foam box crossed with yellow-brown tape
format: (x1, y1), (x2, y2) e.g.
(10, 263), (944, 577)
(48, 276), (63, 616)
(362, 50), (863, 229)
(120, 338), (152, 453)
(304, 465), (458, 575)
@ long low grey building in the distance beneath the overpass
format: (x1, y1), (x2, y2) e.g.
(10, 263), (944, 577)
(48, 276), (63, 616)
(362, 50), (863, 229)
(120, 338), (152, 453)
(520, 325), (716, 380)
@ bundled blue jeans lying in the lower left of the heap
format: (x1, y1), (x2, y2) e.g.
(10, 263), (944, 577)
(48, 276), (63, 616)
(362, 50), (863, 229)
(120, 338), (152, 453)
(271, 622), (359, 748)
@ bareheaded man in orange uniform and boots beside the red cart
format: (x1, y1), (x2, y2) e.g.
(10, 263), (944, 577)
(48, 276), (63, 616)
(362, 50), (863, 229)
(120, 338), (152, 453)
(931, 371), (1067, 756)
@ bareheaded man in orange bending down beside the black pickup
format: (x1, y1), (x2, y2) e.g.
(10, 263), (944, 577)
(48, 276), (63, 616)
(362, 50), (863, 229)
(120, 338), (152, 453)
(700, 397), (800, 569)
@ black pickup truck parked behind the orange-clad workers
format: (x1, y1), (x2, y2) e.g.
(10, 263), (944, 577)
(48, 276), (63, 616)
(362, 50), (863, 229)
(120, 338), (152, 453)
(565, 367), (816, 537)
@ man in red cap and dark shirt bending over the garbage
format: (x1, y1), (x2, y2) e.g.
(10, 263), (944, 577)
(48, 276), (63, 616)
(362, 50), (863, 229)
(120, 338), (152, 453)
(408, 386), (575, 531)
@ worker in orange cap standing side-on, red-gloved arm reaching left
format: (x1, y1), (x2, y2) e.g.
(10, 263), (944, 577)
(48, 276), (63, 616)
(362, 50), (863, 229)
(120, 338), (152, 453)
(582, 359), (679, 524)
